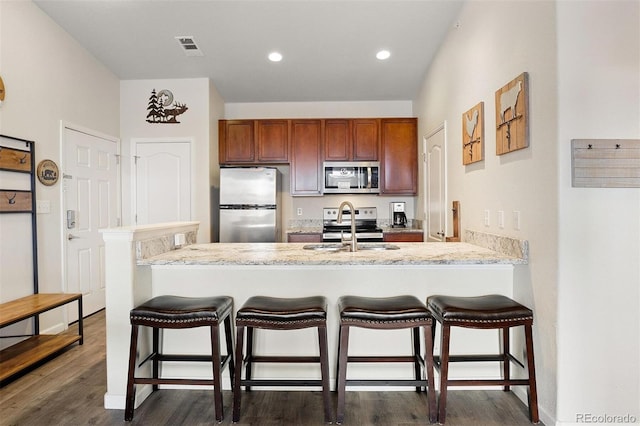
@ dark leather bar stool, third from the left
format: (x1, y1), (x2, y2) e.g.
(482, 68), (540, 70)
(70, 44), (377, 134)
(336, 296), (436, 424)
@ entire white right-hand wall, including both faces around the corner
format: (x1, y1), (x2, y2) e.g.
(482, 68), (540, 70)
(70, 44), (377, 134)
(414, 1), (640, 424)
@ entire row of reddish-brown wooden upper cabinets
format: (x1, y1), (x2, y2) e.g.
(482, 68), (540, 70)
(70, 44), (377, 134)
(218, 118), (418, 195)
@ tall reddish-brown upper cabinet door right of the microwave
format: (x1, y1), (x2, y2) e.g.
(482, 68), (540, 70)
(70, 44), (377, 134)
(380, 118), (418, 195)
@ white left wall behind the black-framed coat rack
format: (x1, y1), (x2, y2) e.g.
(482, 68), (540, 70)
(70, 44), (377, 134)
(0, 1), (120, 330)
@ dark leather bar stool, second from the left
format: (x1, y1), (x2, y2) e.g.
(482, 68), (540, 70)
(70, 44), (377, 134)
(233, 296), (332, 422)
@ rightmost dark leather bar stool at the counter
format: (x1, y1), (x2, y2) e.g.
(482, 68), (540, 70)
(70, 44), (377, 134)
(427, 294), (540, 423)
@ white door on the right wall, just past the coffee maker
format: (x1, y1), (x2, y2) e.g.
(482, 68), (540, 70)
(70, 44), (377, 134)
(423, 123), (447, 241)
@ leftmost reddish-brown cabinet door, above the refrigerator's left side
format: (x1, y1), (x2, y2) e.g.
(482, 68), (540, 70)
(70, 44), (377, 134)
(218, 120), (256, 164)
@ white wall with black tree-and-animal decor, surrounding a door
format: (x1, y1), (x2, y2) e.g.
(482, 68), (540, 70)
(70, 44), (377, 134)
(120, 78), (222, 242)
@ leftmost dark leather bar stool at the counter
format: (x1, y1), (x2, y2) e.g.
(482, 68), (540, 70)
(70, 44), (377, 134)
(124, 296), (234, 422)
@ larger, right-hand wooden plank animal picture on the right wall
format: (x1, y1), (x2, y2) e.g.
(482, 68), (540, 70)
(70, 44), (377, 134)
(496, 72), (529, 155)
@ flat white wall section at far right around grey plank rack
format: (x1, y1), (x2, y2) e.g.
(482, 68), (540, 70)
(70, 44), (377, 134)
(556, 1), (640, 424)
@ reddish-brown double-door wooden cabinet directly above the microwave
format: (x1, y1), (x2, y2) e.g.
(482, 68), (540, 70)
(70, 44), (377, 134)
(324, 119), (380, 161)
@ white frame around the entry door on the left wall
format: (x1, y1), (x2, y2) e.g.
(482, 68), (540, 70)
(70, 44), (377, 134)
(59, 120), (122, 302)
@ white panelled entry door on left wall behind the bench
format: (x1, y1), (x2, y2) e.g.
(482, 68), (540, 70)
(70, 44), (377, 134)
(62, 127), (120, 322)
